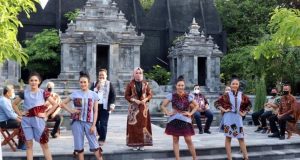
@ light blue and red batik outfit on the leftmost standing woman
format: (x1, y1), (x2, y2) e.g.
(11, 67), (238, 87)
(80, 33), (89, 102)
(20, 89), (50, 144)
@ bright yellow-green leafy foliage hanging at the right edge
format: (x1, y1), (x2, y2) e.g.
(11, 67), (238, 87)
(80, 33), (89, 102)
(253, 8), (300, 90)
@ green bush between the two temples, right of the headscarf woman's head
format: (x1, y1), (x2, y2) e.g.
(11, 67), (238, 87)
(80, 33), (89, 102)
(145, 65), (171, 85)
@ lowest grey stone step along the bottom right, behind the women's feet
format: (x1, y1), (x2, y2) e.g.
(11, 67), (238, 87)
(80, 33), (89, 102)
(104, 144), (300, 160)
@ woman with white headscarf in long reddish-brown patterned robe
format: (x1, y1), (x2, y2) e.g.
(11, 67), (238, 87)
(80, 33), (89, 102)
(125, 67), (152, 150)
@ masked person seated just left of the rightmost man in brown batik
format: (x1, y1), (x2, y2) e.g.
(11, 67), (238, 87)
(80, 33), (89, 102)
(252, 88), (278, 133)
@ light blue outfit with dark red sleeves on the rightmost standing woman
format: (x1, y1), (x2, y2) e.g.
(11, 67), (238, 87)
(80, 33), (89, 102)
(215, 91), (251, 138)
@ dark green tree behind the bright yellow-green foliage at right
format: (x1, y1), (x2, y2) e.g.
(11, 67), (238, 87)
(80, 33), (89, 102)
(216, 0), (299, 93)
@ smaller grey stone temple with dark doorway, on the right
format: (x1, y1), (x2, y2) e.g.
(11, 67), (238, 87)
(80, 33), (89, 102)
(168, 18), (223, 92)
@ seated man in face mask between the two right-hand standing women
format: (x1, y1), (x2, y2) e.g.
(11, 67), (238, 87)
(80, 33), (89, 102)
(192, 85), (213, 134)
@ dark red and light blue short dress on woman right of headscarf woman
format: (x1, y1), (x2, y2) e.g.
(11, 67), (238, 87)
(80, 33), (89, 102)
(165, 93), (195, 136)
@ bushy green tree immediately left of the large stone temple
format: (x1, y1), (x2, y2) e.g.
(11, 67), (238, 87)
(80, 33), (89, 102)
(23, 29), (60, 78)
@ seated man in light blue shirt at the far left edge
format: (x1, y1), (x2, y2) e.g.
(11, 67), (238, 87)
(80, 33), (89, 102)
(0, 85), (26, 149)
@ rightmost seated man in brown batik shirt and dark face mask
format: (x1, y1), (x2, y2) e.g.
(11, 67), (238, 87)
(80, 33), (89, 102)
(269, 84), (296, 140)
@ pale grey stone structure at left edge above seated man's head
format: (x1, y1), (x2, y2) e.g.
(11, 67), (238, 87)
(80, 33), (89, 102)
(0, 60), (21, 87)
